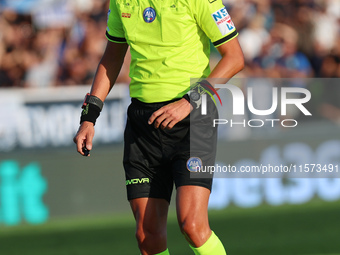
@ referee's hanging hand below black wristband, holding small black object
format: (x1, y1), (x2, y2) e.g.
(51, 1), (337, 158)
(73, 121), (94, 156)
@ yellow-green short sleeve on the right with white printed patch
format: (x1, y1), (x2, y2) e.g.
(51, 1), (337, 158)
(192, 0), (238, 47)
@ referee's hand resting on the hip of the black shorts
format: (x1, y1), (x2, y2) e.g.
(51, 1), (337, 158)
(148, 98), (192, 129)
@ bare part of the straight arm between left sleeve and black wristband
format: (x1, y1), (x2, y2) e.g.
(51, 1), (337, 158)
(90, 42), (128, 101)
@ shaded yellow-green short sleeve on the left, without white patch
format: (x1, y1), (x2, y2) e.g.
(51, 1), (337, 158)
(106, 0), (126, 43)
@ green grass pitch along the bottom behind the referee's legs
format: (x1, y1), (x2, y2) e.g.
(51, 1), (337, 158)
(0, 200), (340, 255)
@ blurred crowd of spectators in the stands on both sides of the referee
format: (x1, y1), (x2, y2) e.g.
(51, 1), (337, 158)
(0, 0), (340, 87)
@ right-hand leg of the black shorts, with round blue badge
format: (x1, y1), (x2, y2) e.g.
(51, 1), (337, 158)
(171, 96), (218, 190)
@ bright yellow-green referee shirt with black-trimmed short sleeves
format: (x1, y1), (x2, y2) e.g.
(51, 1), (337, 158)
(106, 0), (238, 103)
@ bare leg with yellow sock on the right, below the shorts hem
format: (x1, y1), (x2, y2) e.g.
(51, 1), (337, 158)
(176, 186), (226, 255)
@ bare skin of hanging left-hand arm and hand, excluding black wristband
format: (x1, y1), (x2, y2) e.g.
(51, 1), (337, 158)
(73, 41), (128, 156)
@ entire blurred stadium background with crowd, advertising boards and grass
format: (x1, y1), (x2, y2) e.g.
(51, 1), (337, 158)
(0, 0), (340, 255)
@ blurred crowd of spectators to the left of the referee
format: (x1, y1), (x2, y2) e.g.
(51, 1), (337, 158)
(0, 0), (129, 87)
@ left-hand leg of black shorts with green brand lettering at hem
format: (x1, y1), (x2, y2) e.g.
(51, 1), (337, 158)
(123, 102), (173, 202)
